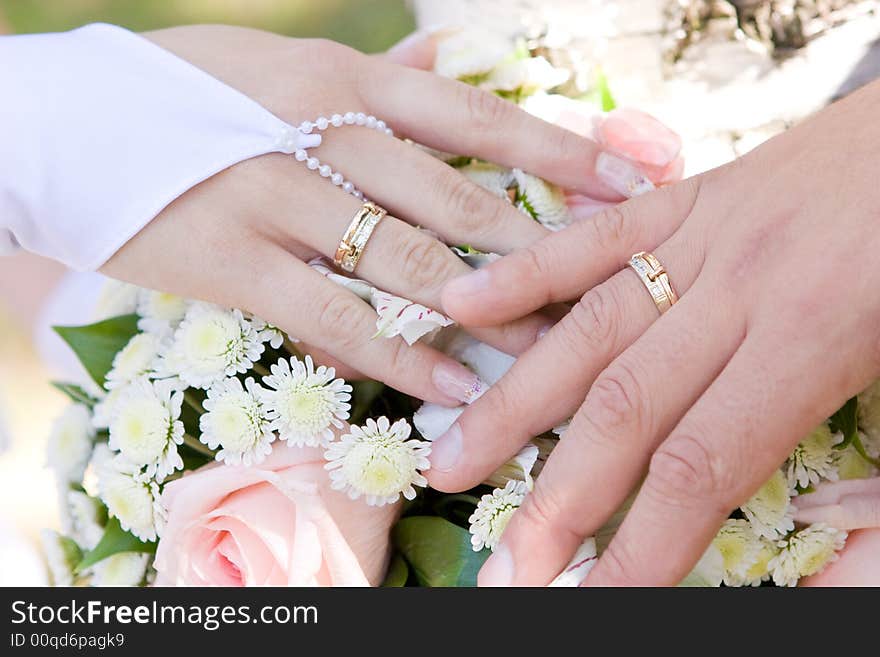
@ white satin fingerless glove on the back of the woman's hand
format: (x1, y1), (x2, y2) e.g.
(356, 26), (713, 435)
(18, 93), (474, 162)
(0, 24), (321, 270)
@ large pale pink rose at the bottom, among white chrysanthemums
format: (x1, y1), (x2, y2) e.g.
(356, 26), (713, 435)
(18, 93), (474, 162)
(155, 443), (399, 586)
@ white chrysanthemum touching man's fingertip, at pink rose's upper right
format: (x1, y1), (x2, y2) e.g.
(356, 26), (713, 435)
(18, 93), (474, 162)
(324, 416), (431, 506)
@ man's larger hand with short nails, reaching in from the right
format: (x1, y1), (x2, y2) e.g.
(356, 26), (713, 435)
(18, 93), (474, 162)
(428, 77), (880, 585)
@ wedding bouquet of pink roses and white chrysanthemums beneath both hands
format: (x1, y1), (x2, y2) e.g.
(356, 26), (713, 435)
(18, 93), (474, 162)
(43, 32), (880, 586)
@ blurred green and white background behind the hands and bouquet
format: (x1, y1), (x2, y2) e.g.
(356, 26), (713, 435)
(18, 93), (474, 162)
(0, 0), (880, 585)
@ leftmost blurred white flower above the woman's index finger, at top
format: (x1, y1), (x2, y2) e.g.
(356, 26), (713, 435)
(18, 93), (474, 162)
(434, 30), (513, 79)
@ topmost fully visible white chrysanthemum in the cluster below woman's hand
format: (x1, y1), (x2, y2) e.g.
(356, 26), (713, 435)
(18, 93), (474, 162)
(161, 303), (265, 389)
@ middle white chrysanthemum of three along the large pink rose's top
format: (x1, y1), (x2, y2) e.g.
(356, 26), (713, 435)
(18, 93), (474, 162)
(262, 356), (352, 447)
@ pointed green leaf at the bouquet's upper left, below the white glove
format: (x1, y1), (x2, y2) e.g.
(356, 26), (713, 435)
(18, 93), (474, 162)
(53, 315), (138, 386)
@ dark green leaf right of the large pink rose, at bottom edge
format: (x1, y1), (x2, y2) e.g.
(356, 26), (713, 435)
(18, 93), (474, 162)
(392, 516), (490, 586)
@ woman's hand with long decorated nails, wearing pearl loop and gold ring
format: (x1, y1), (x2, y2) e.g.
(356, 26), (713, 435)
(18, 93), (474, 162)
(103, 26), (622, 404)
